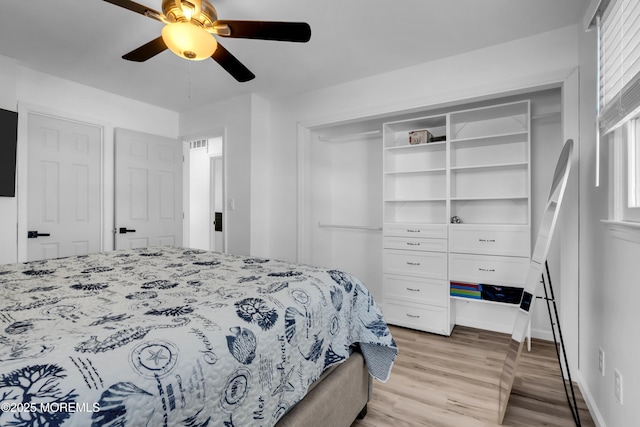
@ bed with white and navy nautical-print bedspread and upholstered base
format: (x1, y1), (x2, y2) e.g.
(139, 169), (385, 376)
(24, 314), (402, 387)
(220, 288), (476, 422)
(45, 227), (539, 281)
(0, 247), (397, 427)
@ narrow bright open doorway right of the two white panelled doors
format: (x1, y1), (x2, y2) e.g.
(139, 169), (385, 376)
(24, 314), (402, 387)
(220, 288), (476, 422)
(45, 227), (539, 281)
(186, 136), (226, 252)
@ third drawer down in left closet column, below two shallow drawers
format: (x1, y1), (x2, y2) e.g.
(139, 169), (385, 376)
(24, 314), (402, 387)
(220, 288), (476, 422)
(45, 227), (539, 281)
(383, 249), (447, 280)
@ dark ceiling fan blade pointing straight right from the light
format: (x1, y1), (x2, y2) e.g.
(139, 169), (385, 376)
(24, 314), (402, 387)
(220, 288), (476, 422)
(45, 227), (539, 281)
(214, 20), (311, 43)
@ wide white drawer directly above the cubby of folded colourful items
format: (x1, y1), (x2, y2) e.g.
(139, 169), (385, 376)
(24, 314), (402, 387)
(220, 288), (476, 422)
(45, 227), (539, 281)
(449, 254), (530, 287)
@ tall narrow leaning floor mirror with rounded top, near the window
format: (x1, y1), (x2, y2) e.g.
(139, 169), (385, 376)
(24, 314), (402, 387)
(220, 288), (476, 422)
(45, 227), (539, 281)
(498, 139), (573, 424)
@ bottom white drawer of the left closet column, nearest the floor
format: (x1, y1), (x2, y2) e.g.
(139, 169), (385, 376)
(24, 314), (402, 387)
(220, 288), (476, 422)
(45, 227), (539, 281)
(383, 299), (451, 335)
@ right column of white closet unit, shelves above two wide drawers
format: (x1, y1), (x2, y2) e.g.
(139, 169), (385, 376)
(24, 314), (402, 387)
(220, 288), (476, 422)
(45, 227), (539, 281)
(448, 101), (531, 326)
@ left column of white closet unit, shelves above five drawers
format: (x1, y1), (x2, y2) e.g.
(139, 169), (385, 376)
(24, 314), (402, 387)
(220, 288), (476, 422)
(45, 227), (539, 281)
(382, 115), (453, 335)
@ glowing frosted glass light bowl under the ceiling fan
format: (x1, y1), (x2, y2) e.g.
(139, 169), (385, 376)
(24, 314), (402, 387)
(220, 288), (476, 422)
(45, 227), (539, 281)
(162, 22), (218, 61)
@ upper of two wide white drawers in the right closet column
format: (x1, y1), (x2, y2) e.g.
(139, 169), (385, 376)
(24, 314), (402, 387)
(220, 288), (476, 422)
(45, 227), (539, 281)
(449, 225), (531, 257)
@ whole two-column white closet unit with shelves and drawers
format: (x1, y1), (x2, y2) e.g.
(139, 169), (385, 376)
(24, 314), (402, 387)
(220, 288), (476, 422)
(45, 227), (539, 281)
(383, 100), (531, 335)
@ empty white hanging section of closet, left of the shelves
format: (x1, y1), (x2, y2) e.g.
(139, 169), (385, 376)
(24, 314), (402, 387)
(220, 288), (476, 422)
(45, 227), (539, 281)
(300, 121), (382, 301)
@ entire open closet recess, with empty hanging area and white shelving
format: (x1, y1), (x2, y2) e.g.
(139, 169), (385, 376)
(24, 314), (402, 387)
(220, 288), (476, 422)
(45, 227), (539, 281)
(300, 89), (563, 338)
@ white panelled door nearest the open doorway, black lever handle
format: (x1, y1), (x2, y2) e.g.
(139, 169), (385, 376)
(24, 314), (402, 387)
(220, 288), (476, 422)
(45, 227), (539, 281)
(115, 129), (182, 249)
